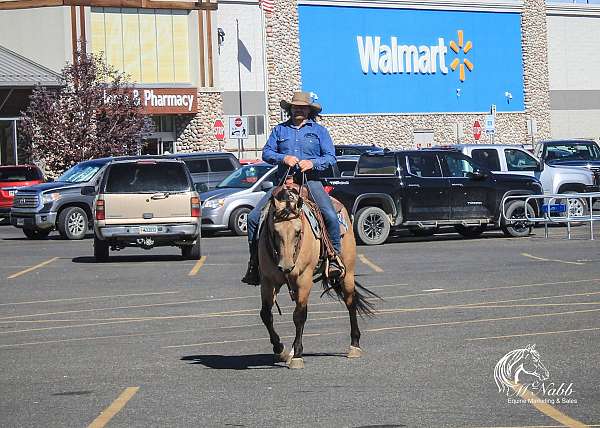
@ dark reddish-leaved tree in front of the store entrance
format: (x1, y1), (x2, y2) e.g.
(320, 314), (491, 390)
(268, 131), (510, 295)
(21, 52), (152, 175)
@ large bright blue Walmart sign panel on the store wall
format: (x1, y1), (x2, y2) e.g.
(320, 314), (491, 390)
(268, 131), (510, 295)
(298, 5), (525, 114)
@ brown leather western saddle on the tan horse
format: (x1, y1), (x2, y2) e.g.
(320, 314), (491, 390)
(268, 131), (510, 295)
(258, 183), (349, 282)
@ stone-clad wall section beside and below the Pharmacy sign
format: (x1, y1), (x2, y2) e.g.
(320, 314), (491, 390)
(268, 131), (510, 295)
(175, 91), (223, 152)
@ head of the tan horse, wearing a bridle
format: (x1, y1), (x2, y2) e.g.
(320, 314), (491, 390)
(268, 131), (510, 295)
(271, 188), (302, 274)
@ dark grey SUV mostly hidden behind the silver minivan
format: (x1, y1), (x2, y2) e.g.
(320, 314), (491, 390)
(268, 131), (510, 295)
(168, 152), (241, 192)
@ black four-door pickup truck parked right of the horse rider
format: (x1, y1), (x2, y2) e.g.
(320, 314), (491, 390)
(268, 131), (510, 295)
(323, 150), (543, 245)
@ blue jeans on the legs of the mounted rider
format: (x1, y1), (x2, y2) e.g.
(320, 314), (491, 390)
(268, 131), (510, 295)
(248, 181), (342, 254)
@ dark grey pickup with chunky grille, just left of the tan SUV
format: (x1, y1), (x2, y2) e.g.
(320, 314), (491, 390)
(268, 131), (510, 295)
(10, 158), (114, 240)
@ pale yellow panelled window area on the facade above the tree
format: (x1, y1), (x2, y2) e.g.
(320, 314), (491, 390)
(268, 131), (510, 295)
(91, 7), (190, 83)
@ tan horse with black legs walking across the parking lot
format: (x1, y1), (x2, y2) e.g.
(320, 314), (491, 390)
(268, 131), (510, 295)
(258, 186), (379, 369)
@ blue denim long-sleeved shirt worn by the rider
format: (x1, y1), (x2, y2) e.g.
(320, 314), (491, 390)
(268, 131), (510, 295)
(263, 119), (336, 180)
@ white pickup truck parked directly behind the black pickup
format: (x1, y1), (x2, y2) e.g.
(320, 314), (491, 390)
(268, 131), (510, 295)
(454, 144), (600, 217)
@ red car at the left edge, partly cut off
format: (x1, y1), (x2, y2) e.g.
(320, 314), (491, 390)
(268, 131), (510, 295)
(0, 165), (45, 219)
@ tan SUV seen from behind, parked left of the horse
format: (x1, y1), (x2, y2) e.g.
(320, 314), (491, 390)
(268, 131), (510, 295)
(89, 157), (201, 261)
